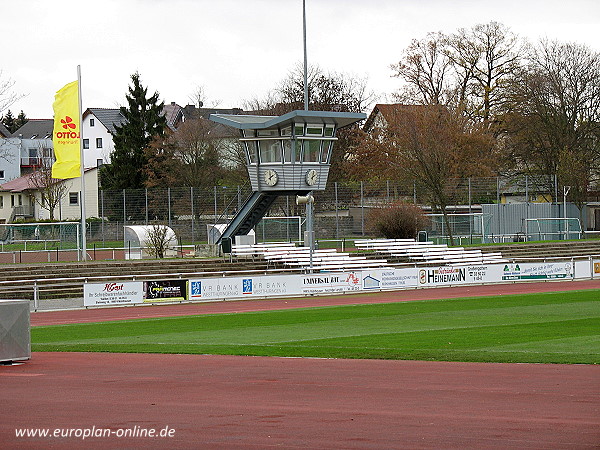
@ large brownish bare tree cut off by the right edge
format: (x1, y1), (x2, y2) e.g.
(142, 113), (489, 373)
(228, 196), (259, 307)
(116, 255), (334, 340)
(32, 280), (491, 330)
(503, 41), (600, 209)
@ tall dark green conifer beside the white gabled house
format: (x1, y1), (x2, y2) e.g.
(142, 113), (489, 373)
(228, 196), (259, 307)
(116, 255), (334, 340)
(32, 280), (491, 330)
(100, 72), (167, 189)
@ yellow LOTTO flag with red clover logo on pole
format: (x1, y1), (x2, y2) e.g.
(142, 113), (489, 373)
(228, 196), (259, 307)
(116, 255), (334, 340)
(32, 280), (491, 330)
(52, 81), (81, 179)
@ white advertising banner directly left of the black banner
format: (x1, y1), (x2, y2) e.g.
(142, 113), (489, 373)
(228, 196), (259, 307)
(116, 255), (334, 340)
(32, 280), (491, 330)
(83, 281), (144, 306)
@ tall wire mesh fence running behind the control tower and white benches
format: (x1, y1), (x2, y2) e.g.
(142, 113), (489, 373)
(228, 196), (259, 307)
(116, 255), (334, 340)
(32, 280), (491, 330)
(87, 177), (576, 244)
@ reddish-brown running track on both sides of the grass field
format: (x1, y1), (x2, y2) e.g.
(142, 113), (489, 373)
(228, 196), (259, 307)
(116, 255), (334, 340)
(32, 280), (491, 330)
(0, 281), (600, 450)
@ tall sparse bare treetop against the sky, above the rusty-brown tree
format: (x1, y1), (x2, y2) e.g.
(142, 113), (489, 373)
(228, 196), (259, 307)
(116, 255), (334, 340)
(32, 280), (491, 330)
(391, 22), (523, 124)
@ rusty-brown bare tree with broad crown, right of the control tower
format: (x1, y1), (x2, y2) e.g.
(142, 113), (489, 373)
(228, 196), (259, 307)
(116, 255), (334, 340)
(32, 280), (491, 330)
(354, 105), (496, 244)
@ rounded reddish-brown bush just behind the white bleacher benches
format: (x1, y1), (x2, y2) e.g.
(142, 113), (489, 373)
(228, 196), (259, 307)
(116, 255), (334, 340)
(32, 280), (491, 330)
(367, 203), (429, 239)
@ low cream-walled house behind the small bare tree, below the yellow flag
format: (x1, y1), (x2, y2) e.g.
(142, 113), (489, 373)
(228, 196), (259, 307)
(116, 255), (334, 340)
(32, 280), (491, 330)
(0, 167), (98, 223)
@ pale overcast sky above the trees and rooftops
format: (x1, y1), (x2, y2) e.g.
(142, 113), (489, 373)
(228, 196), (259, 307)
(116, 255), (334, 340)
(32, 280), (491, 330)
(0, 0), (600, 118)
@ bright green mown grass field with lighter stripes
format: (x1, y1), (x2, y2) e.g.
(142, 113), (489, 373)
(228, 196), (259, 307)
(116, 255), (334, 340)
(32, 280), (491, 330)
(32, 290), (600, 364)
